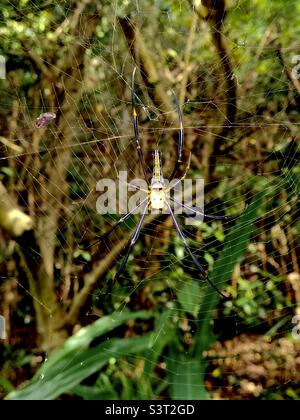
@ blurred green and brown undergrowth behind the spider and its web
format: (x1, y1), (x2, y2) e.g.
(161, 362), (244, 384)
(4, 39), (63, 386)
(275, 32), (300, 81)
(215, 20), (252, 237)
(0, 0), (300, 400)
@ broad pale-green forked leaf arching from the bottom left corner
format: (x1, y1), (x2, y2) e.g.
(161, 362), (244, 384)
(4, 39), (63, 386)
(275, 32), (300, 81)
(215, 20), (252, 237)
(7, 311), (153, 400)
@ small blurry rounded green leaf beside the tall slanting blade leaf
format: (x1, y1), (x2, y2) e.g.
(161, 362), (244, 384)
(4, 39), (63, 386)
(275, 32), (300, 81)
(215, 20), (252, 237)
(177, 280), (202, 317)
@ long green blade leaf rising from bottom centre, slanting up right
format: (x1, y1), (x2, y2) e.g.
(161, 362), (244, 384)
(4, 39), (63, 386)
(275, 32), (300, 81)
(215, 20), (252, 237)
(168, 194), (263, 400)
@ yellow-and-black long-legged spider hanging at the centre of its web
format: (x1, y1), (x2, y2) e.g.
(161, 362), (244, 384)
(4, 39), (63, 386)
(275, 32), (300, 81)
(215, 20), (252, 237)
(97, 68), (239, 299)
